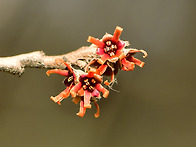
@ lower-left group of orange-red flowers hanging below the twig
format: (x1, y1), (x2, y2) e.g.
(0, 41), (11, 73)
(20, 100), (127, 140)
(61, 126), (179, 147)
(46, 58), (109, 117)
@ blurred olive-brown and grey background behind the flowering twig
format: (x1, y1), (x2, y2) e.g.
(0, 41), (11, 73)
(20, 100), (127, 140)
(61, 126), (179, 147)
(0, 0), (196, 147)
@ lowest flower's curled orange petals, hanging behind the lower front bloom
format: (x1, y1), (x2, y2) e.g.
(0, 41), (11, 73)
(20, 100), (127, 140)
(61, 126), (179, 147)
(72, 96), (100, 117)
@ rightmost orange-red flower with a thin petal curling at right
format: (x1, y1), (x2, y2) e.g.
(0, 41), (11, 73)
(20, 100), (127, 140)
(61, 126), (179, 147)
(120, 49), (148, 71)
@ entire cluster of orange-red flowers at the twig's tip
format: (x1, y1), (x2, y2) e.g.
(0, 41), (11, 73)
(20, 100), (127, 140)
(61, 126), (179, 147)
(46, 26), (147, 117)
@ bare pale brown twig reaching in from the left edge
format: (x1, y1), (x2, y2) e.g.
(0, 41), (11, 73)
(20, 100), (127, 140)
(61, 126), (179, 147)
(0, 45), (97, 76)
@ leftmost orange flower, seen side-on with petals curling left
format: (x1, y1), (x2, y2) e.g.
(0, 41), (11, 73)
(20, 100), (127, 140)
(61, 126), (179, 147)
(46, 58), (76, 105)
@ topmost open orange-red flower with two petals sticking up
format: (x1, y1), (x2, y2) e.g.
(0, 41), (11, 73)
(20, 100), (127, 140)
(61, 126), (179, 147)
(87, 26), (125, 63)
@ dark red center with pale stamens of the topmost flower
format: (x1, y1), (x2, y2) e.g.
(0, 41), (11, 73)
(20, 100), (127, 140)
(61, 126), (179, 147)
(104, 40), (118, 57)
